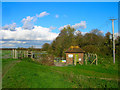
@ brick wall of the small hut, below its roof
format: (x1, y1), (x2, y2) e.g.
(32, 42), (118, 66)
(66, 53), (84, 64)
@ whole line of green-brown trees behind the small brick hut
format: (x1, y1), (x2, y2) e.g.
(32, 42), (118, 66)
(42, 25), (120, 57)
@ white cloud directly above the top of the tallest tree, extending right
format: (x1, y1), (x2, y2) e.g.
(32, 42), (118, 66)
(59, 21), (86, 30)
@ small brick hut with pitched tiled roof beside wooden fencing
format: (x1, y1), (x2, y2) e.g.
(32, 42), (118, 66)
(65, 46), (85, 65)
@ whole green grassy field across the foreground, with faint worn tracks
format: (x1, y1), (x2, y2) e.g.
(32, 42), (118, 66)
(2, 59), (119, 88)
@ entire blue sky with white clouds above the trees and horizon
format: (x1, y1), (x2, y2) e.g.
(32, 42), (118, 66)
(0, 2), (118, 48)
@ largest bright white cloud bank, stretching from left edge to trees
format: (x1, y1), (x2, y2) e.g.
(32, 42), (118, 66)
(0, 26), (58, 40)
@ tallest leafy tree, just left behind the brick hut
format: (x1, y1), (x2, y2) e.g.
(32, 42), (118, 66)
(51, 25), (75, 57)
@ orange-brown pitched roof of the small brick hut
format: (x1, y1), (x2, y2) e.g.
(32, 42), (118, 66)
(65, 46), (85, 53)
